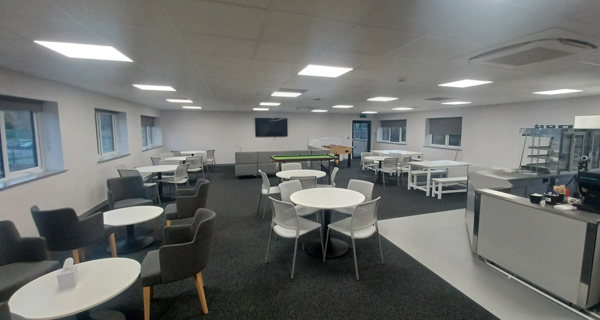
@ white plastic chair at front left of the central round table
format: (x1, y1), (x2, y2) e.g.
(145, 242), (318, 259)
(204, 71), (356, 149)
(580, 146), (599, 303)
(265, 197), (325, 279)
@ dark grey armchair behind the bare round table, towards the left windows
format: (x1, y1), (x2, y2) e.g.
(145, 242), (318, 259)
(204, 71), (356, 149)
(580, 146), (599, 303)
(106, 176), (154, 210)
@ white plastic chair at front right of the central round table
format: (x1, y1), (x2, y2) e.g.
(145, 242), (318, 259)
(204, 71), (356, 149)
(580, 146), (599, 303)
(323, 197), (383, 280)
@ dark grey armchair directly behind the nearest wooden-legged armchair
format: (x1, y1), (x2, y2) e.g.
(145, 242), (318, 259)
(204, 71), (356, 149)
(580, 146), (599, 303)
(165, 179), (210, 226)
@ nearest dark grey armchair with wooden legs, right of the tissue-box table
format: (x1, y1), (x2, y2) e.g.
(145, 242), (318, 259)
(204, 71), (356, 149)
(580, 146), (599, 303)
(141, 208), (216, 320)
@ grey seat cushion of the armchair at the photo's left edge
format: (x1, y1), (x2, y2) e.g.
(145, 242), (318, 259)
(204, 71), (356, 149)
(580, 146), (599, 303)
(0, 260), (59, 301)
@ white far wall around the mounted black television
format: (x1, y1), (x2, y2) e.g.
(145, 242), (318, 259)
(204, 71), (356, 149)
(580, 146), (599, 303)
(160, 111), (359, 164)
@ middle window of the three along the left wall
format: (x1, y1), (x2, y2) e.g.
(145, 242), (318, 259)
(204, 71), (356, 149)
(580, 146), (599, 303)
(96, 110), (129, 160)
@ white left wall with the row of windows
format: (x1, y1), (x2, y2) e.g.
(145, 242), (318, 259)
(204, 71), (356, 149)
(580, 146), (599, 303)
(0, 69), (160, 235)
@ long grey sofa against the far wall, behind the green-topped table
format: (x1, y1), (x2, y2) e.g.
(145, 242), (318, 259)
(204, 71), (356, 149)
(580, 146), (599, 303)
(235, 149), (329, 177)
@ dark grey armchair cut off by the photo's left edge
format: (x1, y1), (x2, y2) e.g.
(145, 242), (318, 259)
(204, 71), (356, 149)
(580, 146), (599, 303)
(0, 220), (59, 302)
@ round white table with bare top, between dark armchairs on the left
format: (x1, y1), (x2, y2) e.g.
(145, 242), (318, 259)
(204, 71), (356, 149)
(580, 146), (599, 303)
(104, 206), (163, 253)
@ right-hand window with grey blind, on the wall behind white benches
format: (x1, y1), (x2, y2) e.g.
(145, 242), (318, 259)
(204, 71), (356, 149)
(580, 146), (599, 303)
(425, 117), (462, 149)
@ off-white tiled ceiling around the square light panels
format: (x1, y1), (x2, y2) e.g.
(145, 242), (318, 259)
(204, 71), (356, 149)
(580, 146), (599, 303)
(0, 0), (600, 113)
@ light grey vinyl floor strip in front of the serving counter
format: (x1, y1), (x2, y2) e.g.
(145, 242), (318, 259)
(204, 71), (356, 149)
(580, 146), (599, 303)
(379, 209), (584, 320)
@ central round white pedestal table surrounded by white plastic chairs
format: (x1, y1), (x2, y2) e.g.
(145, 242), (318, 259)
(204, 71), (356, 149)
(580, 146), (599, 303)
(290, 188), (365, 258)
